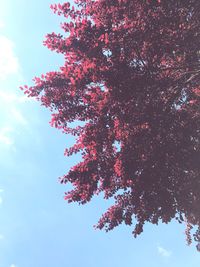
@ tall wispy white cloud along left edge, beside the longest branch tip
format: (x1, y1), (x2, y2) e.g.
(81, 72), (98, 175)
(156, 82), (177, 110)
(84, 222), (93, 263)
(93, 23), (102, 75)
(0, 33), (28, 149)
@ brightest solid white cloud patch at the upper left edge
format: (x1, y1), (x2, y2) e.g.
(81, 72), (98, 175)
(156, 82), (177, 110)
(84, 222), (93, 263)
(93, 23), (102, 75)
(0, 35), (19, 79)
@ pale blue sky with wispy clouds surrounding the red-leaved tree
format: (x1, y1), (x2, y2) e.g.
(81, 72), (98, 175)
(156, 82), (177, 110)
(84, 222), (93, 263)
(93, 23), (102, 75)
(0, 0), (200, 267)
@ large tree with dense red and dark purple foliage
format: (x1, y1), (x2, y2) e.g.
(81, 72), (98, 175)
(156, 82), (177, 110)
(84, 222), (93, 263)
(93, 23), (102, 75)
(23, 0), (200, 248)
